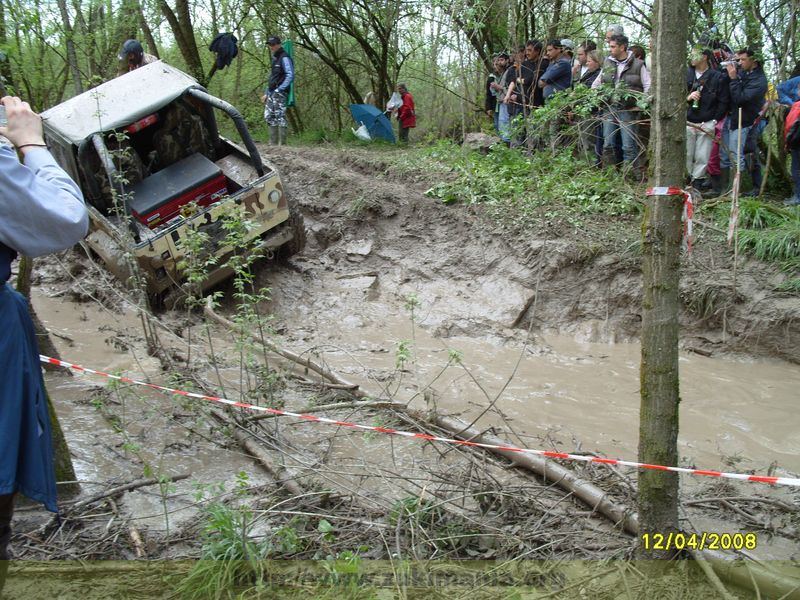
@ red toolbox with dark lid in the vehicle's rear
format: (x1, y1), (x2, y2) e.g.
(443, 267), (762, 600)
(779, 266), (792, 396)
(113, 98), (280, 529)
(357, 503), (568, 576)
(128, 154), (228, 229)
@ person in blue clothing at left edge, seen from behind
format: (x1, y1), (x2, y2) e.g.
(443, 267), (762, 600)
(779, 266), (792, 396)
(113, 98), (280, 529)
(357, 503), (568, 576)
(0, 96), (89, 576)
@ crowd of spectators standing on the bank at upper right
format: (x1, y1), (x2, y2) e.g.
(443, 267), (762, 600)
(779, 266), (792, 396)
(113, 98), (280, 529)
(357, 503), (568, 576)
(485, 24), (800, 206)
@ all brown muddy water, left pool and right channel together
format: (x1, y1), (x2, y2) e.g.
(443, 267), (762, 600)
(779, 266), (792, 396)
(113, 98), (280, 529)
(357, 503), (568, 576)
(35, 275), (800, 512)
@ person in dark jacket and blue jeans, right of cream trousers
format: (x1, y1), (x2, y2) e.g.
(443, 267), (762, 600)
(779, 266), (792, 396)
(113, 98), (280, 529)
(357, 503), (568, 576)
(719, 48), (767, 193)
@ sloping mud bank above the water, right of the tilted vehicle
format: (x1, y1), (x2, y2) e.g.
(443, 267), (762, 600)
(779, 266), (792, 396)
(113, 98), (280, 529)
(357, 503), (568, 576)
(262, 146), (800, 362)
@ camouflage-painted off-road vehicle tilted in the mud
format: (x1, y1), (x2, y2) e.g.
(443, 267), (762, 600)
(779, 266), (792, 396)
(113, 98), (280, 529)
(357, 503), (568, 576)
(42, 62), (305, 298)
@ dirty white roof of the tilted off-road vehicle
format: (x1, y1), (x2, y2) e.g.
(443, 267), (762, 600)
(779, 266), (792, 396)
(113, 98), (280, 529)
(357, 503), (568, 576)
(42, 61), (198, 145)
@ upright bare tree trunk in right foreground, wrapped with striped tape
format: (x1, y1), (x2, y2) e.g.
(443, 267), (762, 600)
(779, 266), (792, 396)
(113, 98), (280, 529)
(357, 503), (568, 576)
(639, 0), (689, 558)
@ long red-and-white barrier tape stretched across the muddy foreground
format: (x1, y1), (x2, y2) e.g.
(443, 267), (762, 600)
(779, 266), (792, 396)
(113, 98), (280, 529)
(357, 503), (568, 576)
(39, 354), (800, 487)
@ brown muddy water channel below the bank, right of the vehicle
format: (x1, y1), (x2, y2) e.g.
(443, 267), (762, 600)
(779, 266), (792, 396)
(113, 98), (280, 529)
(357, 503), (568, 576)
(266, 277), (800, 482)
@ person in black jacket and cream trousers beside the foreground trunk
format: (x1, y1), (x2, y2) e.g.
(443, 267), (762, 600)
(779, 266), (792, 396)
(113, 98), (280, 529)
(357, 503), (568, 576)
(686, 48), (730, 189)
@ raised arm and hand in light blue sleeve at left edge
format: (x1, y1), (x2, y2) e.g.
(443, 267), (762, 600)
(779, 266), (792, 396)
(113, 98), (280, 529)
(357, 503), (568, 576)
(0, 96), (89, 256)
